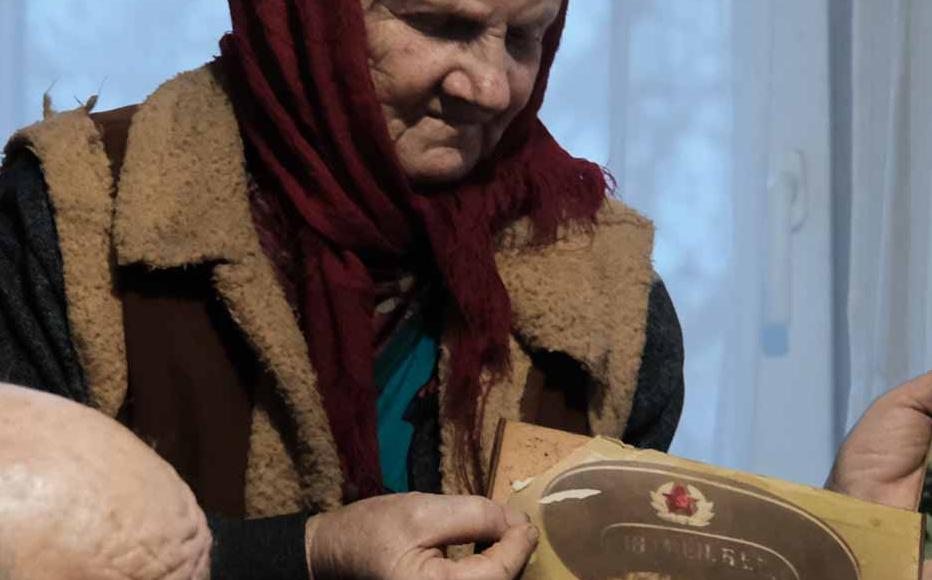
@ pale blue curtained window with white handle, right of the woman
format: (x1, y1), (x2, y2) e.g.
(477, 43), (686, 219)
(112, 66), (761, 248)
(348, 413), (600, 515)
(546, 0), (837, 484)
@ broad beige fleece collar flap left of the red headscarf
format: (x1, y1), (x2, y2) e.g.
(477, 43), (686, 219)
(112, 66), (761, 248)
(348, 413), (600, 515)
(114, 66), (255, 268)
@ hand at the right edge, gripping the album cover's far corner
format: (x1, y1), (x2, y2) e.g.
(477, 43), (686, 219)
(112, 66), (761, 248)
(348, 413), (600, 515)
(825, 374), (932, 510)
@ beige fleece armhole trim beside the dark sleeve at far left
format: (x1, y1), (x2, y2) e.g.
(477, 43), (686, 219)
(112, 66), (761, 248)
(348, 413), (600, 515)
(6, 108), (127, 417)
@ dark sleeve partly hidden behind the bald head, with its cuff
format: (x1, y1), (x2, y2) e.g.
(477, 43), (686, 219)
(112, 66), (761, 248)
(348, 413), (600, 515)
(0, 151), (308, 580)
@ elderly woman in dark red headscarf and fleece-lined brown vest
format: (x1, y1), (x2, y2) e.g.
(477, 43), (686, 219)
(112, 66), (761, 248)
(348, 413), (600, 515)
(0, 0), (924, 579)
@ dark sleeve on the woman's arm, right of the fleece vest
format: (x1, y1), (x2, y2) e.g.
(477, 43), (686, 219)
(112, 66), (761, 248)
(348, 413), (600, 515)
(623, 280), (684, 451)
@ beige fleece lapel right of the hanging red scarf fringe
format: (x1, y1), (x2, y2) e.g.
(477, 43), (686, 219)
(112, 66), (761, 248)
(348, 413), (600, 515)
(498, 201), (654, 437)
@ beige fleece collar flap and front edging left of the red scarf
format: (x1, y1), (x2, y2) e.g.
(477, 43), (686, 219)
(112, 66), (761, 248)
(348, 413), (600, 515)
(115, 67), (342, 517)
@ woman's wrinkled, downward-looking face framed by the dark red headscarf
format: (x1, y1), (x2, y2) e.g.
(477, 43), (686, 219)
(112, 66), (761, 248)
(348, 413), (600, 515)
(361, 0), (561, 184)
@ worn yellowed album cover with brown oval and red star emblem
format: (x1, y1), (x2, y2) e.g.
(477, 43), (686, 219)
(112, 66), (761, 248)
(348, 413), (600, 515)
(489, 423), (923, 580)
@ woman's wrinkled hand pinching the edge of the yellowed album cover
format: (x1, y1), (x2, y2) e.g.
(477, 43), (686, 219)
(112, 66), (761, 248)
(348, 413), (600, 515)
(307, 493), (538, 580)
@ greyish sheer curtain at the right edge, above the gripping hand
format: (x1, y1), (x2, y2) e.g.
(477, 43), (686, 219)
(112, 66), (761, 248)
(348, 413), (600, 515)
(847, 0), (932, 424)
